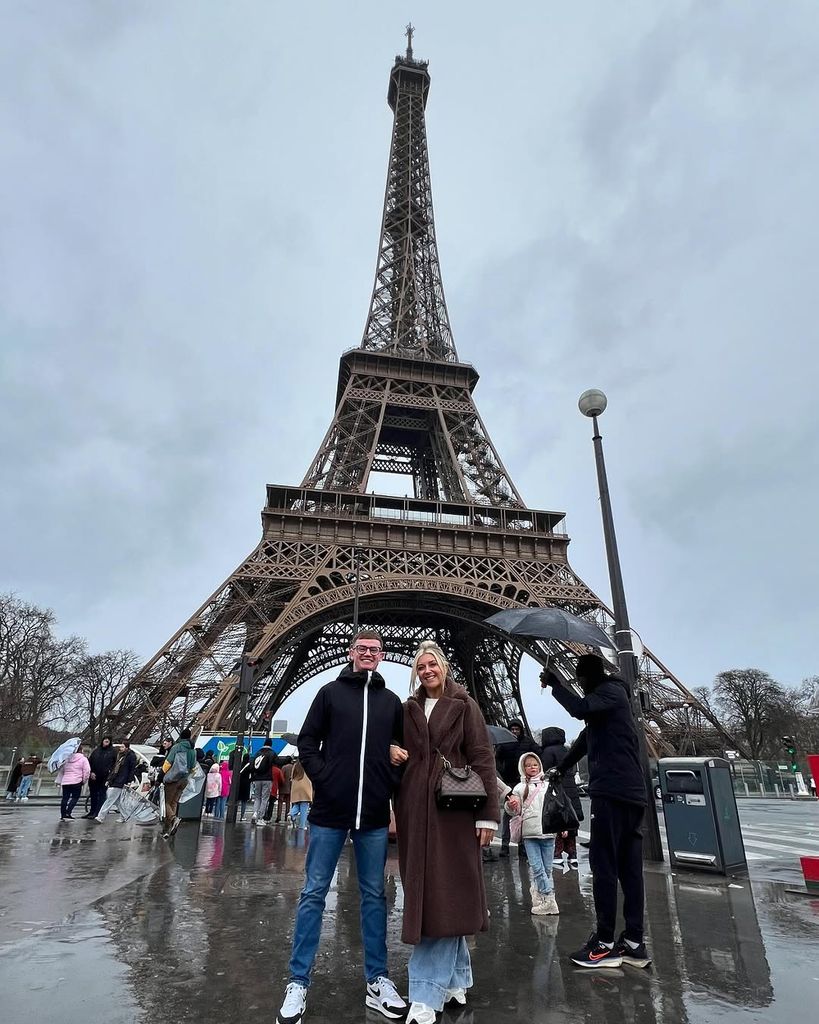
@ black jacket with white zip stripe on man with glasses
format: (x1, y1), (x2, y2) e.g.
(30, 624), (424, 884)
(298, 664), (403, 830)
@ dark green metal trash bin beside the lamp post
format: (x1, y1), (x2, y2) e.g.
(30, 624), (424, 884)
(658, 758), (747, 874)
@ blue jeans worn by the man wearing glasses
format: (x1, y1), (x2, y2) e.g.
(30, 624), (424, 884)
(290, 825), (387, 985)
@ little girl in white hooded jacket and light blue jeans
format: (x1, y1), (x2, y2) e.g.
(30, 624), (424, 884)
(507, 754), (560, 914)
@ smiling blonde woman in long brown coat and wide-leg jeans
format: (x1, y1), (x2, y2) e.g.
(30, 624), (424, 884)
(391, 641), (499, 1024)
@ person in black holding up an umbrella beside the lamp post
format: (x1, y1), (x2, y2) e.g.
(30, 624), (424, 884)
(542, 654), (651, 968)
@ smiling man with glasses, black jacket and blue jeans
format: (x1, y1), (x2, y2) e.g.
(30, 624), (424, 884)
(276, 630), (406, 1024)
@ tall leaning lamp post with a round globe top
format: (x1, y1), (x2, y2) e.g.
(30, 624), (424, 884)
(577, 388), (663, 860)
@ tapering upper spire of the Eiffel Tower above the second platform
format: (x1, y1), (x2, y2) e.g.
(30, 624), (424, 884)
(360, 25), (458, 362)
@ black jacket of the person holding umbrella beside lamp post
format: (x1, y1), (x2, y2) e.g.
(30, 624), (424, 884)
(552, 676), (646, 804)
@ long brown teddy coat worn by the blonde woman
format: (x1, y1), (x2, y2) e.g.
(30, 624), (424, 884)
(395, 679), (499, 944)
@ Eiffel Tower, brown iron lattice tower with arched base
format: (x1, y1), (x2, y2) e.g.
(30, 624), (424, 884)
(105, 27), (730, 754)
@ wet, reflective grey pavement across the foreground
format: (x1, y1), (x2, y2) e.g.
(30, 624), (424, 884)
(0, 805), (819, 1024)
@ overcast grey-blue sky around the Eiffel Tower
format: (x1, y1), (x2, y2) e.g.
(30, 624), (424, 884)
(0, 0), (819, 726)
